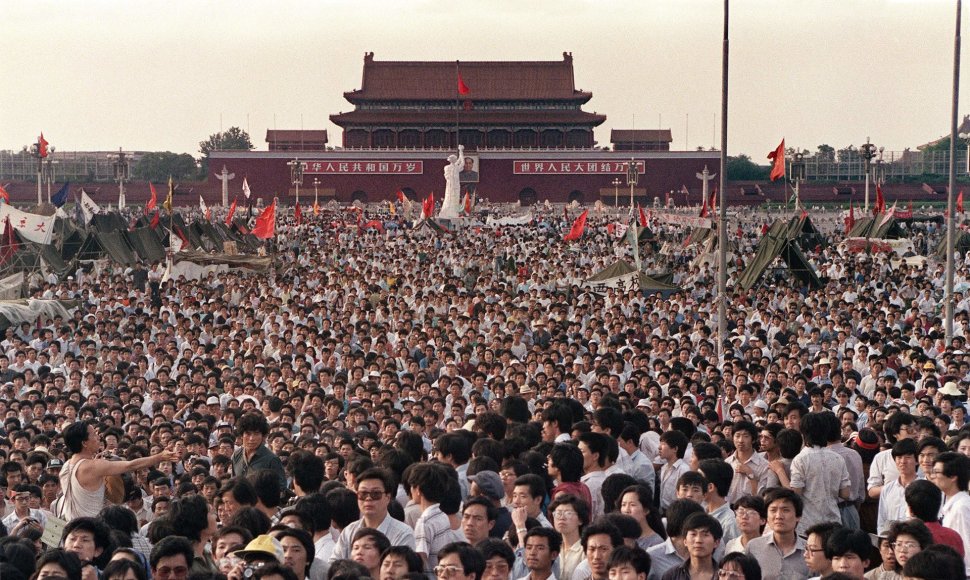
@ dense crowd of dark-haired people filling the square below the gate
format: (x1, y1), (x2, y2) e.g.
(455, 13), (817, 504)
(0, 201), (970, 580)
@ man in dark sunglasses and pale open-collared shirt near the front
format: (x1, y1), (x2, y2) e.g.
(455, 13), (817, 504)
(330, 467), (414, 563)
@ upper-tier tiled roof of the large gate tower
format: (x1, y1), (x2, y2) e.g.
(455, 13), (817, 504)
(344, 53), (592, 103)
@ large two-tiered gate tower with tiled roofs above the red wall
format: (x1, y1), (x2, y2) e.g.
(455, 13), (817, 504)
(330, 52), (606, 150)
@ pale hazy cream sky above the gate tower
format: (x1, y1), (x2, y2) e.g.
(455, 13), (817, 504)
(0, 0), (970, 163)
